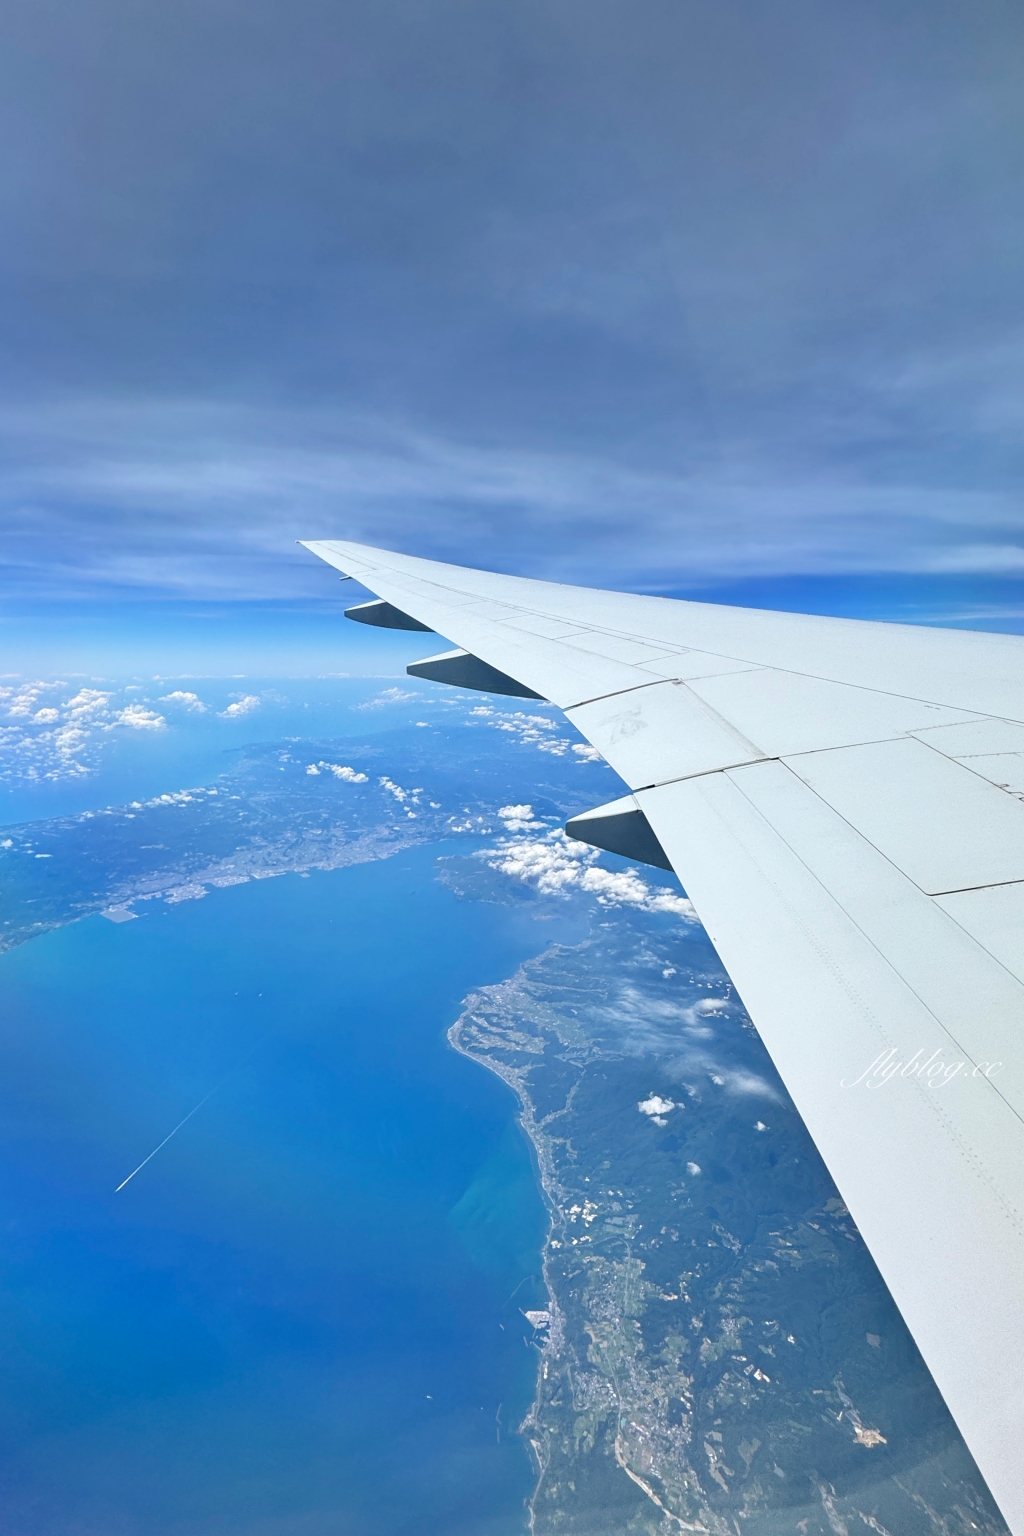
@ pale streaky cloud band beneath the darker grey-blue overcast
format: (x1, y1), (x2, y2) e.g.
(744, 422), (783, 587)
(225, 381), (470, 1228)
(0, 393), (1024, 599)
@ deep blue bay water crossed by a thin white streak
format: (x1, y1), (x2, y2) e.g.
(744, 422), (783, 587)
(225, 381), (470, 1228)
(0, 849), (579, 1536)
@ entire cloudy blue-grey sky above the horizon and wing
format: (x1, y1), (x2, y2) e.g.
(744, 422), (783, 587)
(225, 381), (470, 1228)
(0, 0), (1024, 656)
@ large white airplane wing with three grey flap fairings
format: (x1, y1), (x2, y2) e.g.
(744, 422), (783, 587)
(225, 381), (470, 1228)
(306, 541), (1024, 1536)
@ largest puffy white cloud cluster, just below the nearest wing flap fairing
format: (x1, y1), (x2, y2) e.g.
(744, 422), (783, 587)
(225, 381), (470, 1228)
(482, 828), (697, 922)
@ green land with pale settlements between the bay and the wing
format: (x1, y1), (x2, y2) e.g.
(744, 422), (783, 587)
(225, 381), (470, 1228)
(448, 915), (1006, 1536)
